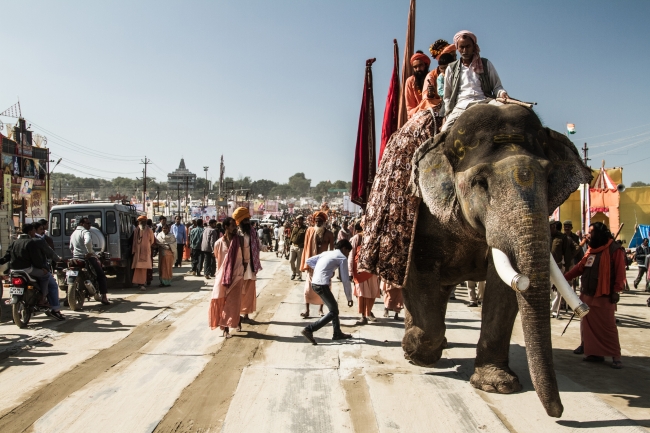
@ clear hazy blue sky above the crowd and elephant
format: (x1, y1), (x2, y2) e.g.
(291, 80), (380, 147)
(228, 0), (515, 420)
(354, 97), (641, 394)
(0, 0), (650, 185)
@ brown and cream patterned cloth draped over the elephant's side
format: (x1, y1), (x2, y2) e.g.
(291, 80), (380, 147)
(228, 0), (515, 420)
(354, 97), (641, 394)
(359, 110), (440, 288)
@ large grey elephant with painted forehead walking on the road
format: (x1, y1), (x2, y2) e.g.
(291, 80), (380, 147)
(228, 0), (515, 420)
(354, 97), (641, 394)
(402, 104), (592, 417)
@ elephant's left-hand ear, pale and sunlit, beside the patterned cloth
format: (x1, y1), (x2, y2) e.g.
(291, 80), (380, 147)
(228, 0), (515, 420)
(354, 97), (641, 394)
(410, 131), (456, 218)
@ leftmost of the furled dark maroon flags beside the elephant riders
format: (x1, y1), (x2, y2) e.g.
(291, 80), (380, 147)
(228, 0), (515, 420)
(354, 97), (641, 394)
(350, 59), (377, 210)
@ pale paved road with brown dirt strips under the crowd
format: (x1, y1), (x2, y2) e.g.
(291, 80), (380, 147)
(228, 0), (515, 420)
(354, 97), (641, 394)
(0, 254), (650, 433)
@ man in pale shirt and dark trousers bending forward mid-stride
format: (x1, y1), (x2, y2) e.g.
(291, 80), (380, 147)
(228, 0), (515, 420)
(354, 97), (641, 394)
(301, 240), (353, 345)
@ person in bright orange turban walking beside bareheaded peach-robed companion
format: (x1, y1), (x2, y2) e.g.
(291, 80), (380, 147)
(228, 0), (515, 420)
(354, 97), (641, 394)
(232, 207), (262, 321)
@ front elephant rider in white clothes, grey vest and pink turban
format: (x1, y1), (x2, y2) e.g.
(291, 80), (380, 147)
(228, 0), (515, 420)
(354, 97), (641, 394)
(442, 30), (508, 131)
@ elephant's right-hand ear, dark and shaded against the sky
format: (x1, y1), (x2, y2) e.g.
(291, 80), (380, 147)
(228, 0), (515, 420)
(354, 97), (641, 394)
(540, 128), (593, 213)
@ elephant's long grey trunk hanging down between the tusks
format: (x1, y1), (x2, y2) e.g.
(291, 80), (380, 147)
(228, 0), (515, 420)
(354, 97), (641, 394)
(514, 223), (564, 417)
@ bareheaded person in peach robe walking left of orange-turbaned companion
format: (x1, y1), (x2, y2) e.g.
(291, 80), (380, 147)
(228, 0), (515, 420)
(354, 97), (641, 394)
(208, 217), (244, 338)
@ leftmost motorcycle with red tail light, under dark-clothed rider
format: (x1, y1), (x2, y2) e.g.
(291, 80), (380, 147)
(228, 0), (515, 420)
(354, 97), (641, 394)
(9, 270), (50, 328)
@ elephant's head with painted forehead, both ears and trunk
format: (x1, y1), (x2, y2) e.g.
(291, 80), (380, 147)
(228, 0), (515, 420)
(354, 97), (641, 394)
(413, 104), (591, 416)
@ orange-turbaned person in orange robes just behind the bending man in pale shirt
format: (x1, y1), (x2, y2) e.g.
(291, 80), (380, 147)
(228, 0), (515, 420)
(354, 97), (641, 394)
(300, 210), (334, 319)
